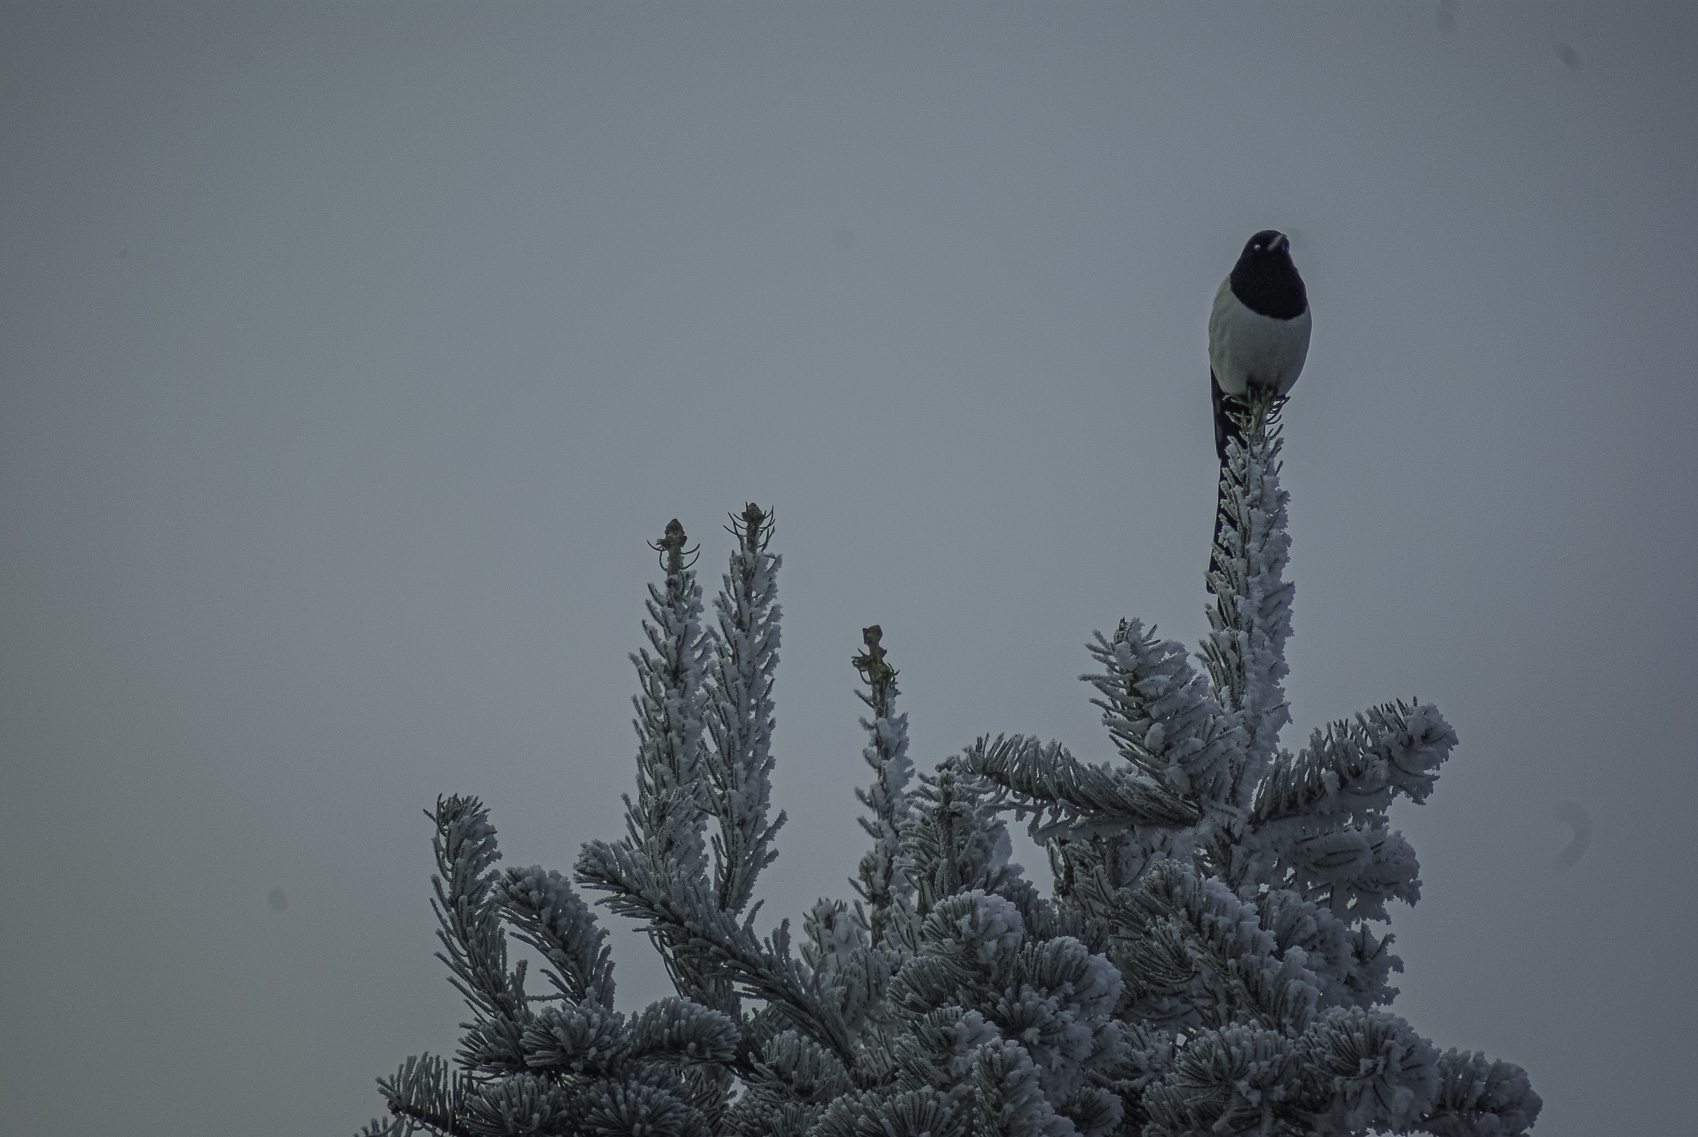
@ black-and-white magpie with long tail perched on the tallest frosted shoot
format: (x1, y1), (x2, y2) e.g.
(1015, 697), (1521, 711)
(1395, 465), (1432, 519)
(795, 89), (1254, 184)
(1209, 229), (1309, 592)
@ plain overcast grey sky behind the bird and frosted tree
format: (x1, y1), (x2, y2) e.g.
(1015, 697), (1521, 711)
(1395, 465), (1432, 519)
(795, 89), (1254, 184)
(0, 2), (1698, 1137)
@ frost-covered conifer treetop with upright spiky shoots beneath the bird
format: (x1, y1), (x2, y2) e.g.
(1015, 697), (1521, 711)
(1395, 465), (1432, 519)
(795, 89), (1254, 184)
(365, 422), (1540, 1137)
